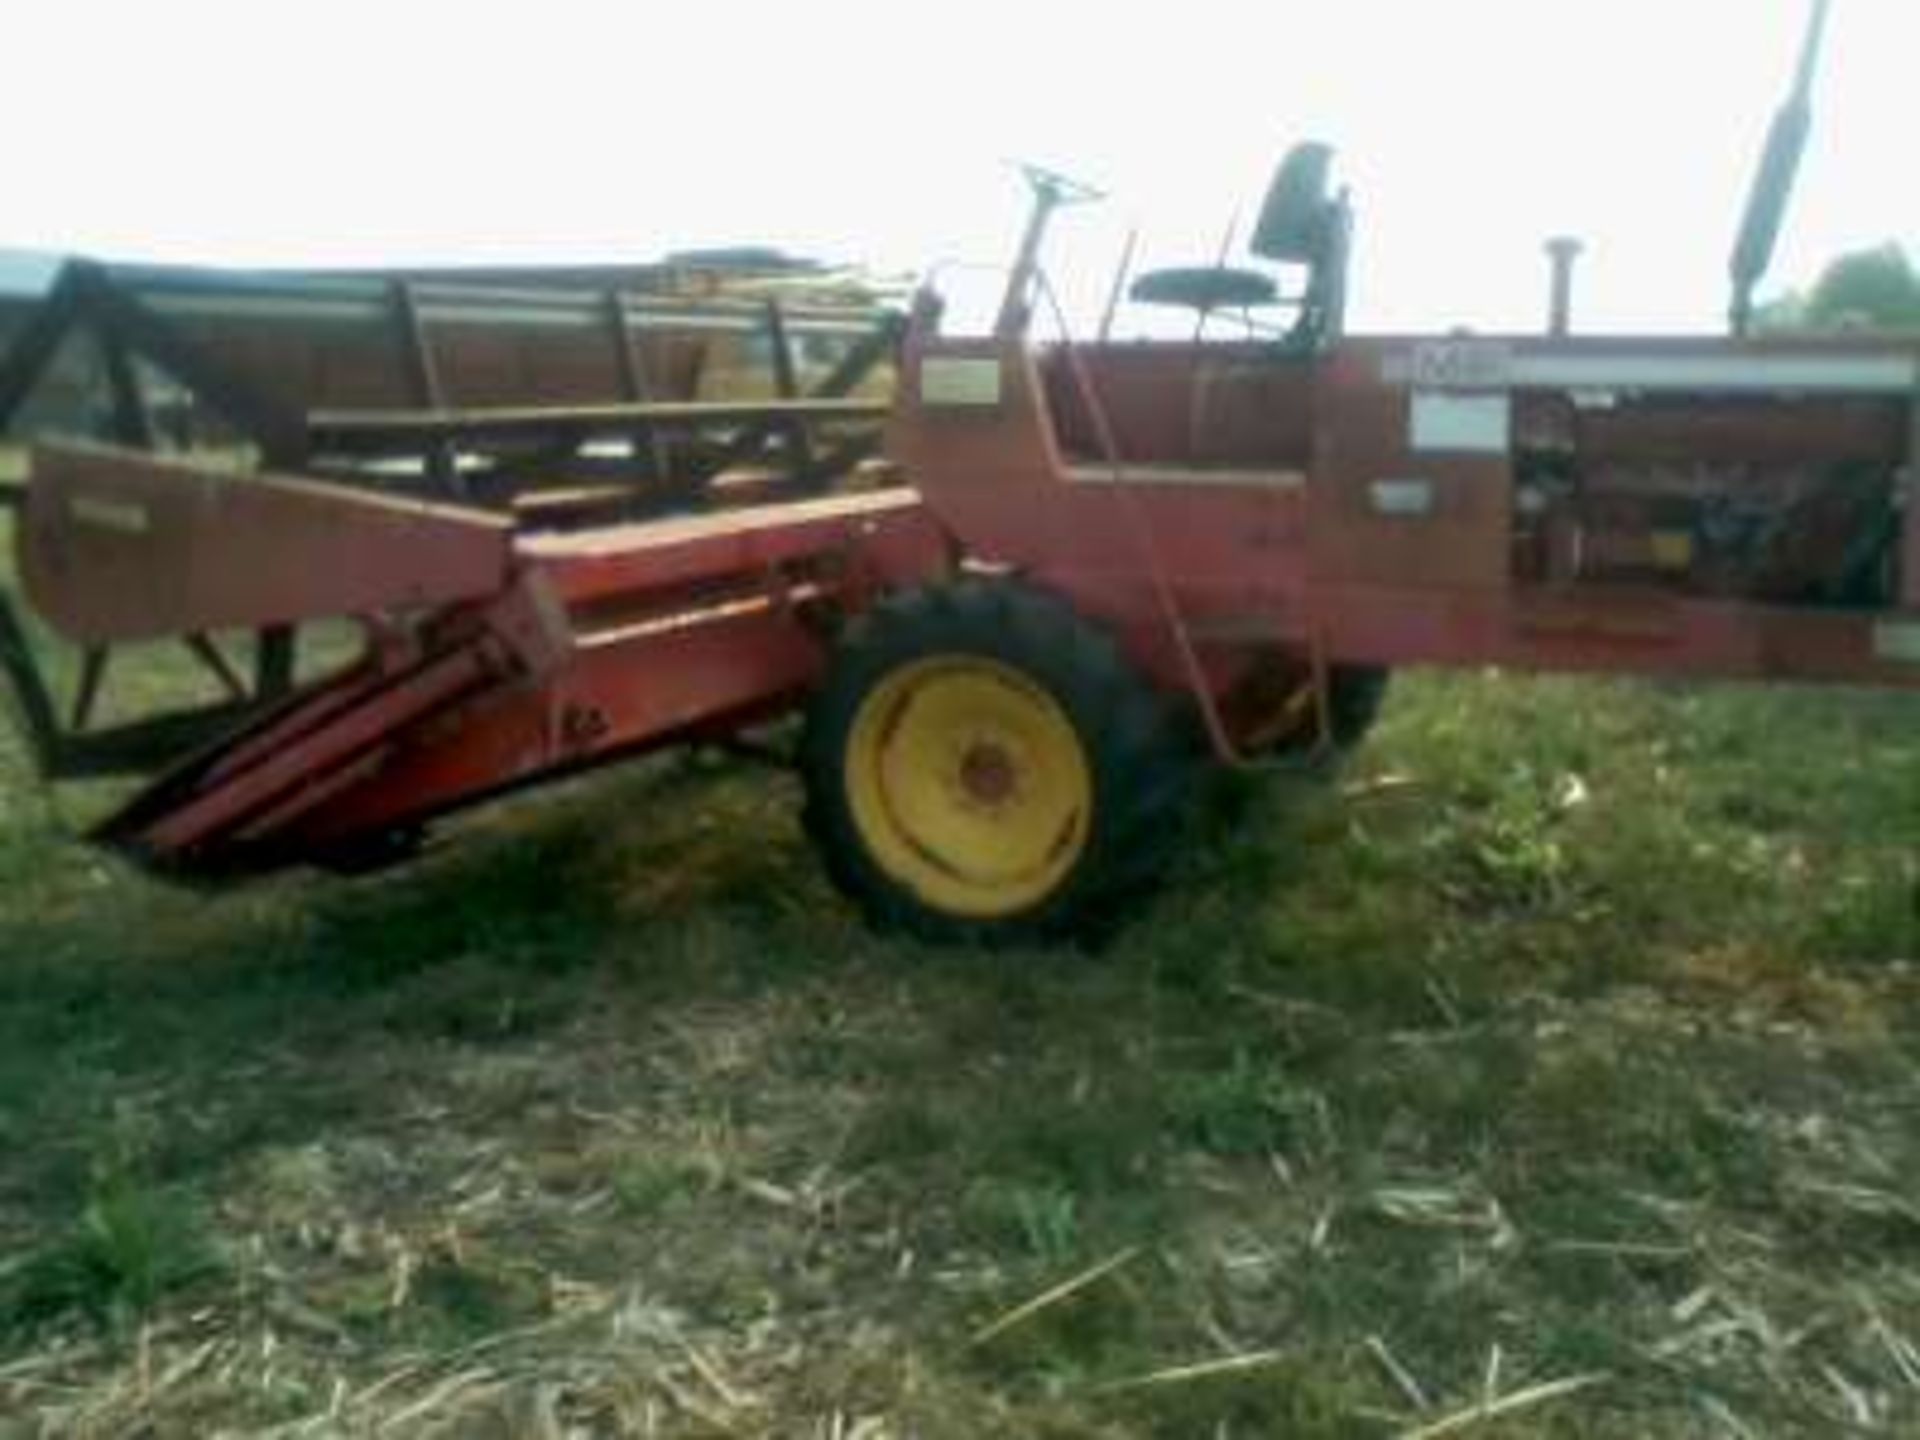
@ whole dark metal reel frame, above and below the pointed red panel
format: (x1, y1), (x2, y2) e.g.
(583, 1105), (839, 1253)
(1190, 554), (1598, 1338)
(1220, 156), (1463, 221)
(0, 261), (900, 778)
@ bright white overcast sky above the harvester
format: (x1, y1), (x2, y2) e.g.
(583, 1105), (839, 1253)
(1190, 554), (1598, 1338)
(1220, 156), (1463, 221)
(0, 0), (1920, 330)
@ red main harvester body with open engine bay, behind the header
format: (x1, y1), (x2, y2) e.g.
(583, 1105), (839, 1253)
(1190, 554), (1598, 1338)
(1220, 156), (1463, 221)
(889, 324), (1920, 744)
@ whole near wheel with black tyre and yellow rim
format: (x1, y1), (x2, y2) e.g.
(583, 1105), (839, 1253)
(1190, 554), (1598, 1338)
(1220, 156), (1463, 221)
(803, 580), (1194, 945)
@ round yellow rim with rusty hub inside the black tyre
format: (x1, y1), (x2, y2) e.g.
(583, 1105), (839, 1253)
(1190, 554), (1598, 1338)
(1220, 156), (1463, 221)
(847, 655), (1092, 920)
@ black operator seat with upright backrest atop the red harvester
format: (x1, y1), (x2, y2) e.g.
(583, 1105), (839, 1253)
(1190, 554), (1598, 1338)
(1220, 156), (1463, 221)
(1127, 140), (1352, 348)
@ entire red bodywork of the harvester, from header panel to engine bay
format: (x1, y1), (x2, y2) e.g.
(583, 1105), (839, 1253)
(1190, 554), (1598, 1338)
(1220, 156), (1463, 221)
(23, 299), (1920, 866)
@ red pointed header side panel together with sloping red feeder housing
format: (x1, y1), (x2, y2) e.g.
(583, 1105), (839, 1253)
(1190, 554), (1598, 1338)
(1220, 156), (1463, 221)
(19, 449), (952, 868)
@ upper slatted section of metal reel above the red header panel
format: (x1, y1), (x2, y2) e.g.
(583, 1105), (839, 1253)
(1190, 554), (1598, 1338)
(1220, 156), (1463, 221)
(0, 261), (900, 518)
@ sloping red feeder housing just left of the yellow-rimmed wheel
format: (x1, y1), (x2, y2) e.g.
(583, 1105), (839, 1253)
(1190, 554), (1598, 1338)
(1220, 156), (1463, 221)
(76, 468), (948, 870)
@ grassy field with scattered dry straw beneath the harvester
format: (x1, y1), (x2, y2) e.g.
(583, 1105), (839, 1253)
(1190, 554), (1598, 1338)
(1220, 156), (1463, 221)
(0, 652), (1920, 1440)
